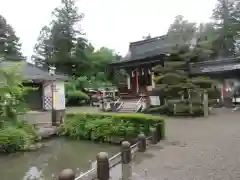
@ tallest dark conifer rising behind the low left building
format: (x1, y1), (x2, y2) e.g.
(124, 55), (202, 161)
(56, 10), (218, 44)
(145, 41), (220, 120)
(34, 0), (87, 75)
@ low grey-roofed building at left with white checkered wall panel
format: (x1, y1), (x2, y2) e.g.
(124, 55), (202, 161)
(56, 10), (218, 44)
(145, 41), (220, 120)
(0, 61), (68, 111)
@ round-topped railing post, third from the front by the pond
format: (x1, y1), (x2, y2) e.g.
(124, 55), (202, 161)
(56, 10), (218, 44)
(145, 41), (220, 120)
(121, 141), (132, 180)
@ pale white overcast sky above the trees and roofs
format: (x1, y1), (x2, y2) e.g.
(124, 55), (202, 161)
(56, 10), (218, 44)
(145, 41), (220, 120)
(0, 0), (216, 57)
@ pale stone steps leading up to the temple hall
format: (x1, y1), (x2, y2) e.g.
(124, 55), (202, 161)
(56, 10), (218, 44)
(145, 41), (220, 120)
(118, 99), (139, 113)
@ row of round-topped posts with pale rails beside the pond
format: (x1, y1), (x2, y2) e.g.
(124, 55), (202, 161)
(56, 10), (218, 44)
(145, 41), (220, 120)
(58, 124), (162, 180)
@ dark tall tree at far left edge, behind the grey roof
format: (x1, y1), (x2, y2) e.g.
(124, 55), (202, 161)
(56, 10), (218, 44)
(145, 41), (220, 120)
(0, 15), (23, 61)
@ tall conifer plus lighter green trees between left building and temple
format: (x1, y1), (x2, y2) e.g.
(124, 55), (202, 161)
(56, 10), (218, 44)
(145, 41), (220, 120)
(33, 0), (119, 82)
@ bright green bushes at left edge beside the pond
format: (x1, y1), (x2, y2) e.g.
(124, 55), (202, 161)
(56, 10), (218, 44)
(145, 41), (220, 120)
(0, 64), (37, 153)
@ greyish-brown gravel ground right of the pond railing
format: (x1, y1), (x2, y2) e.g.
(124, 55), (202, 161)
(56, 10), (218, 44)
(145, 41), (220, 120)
(133, 109), (240, 180)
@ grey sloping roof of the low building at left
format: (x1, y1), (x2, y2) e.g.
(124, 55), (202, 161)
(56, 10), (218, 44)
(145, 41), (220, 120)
(0, 61), (68, 80)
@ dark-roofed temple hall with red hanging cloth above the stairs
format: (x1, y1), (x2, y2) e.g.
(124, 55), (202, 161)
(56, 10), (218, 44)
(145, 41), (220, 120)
(108, 36), (176, 97)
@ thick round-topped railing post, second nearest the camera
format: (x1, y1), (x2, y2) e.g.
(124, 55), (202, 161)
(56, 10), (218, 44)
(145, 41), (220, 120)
(97, 152), (110, 180)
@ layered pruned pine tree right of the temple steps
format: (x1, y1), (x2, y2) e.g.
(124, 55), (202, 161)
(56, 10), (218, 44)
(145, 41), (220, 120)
(153, 47), (220, 116)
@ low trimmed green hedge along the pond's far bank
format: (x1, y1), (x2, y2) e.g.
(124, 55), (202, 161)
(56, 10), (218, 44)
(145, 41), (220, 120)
(62, 113), (165, 142)
